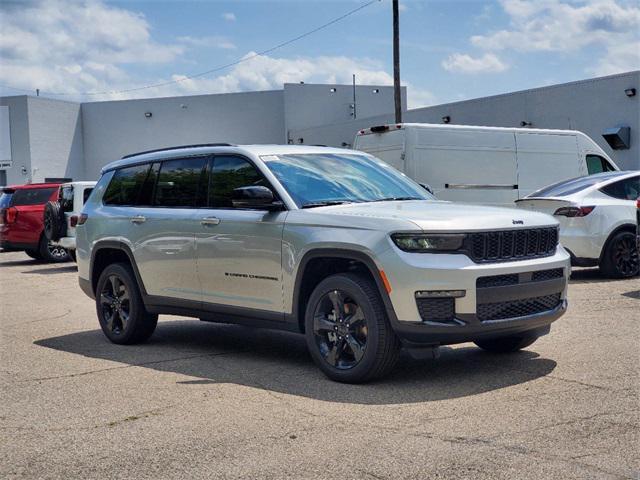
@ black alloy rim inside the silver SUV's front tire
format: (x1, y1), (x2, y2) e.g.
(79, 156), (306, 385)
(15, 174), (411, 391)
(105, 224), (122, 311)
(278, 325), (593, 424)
(313, 290), (368, 370)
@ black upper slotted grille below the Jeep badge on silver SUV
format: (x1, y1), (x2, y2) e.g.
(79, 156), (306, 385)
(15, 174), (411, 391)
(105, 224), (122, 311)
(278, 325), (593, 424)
(468, 227), (558, 262)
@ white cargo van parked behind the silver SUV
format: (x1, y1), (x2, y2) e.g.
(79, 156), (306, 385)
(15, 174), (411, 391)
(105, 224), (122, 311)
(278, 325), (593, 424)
(353, 123), (619, 206)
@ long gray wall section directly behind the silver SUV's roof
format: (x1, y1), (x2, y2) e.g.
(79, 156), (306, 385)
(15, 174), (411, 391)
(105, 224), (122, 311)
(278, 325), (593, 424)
(82, 90), (285, 179)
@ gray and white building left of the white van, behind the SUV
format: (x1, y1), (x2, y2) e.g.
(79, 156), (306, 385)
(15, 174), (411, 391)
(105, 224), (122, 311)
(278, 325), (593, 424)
(0, 84), (406, 185)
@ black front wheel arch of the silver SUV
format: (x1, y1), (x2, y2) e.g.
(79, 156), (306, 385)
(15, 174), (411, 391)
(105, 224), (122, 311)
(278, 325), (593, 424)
(292, 248), (397, 332)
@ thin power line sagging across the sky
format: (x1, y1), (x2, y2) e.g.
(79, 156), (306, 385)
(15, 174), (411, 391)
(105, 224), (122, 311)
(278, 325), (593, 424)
(0, 0), (382, 96)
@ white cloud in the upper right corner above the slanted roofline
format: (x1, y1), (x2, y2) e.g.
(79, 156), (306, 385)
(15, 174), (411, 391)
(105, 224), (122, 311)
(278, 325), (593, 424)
(471, 0), (640, 75)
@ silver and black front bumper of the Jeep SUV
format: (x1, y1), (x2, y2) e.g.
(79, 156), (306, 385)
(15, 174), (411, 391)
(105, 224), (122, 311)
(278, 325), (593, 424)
(380, 246), (571, 345)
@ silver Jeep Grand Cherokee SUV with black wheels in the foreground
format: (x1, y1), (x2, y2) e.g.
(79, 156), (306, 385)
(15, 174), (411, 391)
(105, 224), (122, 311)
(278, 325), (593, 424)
(76, 144), (570, 382)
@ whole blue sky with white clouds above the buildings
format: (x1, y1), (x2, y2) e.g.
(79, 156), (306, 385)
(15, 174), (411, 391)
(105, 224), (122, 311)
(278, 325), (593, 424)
(0, 0), (640, 107)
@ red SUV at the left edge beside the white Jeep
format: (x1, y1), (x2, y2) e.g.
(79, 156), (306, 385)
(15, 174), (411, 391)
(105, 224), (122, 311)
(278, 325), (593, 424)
(0, 183), (70, 262)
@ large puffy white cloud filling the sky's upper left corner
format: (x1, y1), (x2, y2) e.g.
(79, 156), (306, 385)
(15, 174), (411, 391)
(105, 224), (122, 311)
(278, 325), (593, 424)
(0, 0), (185, 96)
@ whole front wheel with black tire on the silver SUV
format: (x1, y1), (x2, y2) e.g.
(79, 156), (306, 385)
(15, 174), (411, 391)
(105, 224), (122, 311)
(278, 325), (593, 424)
(305, 273), (400, 383)
